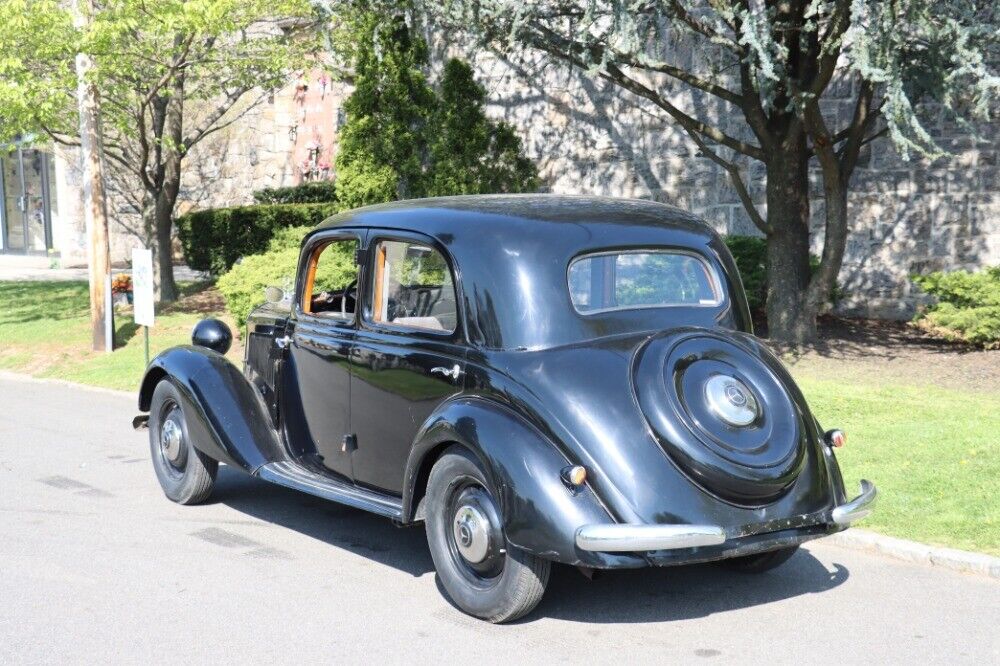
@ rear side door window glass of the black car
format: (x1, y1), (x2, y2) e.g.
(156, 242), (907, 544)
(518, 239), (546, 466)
(370, 241), (458, 332)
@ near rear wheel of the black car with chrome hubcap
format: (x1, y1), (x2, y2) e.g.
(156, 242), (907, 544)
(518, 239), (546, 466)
(426, 446), (551, 622)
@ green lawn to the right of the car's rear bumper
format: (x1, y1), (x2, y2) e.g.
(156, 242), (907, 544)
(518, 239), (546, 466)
(795, 373), (1000, 555)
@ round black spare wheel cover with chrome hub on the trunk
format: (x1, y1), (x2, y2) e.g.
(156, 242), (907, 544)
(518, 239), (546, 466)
(633, 329), (805, 505)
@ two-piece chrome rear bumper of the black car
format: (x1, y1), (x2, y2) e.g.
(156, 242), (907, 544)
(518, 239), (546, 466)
(576, 481), (877, 553)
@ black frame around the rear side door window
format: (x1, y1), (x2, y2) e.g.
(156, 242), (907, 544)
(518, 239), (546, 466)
(358, 229), (466, 342)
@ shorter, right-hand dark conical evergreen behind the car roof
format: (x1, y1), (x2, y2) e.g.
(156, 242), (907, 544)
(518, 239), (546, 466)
(428, 58), (538, 196)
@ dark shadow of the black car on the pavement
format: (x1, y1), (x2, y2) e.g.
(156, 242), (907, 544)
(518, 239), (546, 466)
(212, 466), (850, 623)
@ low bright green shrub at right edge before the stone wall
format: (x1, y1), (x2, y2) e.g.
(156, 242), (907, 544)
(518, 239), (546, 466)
(913, 266), (1000, 349)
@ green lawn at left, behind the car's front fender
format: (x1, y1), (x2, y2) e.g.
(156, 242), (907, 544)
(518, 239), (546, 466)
(0, 282), (240, 391)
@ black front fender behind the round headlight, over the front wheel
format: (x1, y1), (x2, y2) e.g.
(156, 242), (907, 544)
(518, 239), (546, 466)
(139, 345), (286, 473)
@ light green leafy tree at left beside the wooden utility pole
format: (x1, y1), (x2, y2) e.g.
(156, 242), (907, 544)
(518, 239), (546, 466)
(0, 0), (314, 301)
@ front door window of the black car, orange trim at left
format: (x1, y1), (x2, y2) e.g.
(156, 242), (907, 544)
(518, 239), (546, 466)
(302, 238), (358, 318)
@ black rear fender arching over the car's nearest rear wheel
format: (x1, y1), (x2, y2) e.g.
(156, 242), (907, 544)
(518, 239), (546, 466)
(403, 397), (645, 568)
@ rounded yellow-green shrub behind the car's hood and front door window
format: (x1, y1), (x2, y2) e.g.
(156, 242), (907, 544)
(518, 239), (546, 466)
(216, 227), (357, 327)
